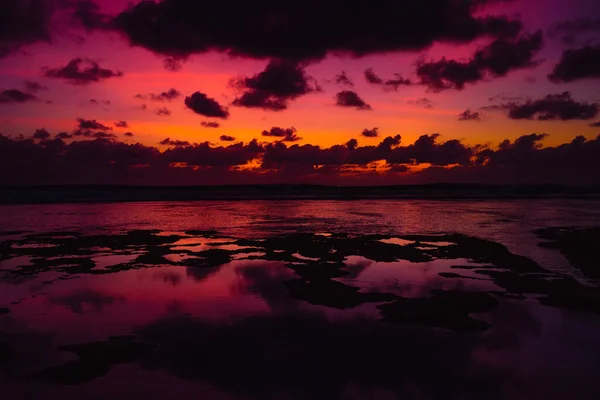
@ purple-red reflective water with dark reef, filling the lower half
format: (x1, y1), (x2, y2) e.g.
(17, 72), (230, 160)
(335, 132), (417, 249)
(0, 199), (600, 400)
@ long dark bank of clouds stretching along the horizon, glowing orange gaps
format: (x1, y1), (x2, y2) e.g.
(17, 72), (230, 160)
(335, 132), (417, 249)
(0, 127), (600, 184)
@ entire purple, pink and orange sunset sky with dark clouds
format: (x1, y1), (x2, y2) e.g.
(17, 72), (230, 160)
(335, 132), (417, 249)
(0, 0), (600, 184)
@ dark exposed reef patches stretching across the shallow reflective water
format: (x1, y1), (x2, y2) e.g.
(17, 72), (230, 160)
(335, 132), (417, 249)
(0, 228), (600, 331)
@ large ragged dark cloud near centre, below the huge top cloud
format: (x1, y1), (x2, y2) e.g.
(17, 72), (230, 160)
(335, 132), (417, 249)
(231, 60), (319, 111)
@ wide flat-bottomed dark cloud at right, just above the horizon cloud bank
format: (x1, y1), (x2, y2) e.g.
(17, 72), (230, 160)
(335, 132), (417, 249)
(503, 92), (598, 121)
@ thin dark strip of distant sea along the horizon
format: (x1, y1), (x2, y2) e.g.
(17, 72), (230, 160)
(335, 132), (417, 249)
(0, 183), (600, 204)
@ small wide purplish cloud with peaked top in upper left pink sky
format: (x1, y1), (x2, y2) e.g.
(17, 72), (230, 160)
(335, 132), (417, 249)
(43, 58), (123, 85)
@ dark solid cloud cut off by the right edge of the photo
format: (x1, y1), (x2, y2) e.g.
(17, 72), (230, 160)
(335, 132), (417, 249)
(548, 45), (600, 83)
